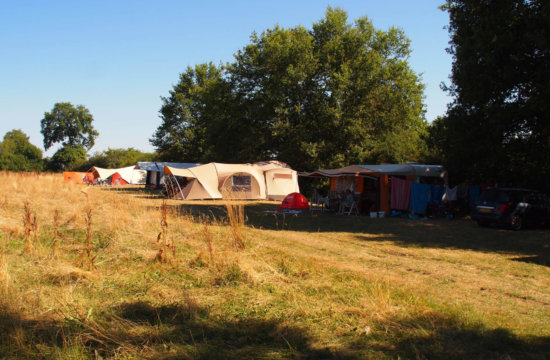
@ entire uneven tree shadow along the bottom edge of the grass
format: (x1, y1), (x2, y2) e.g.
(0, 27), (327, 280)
(0, 302), (550, 360)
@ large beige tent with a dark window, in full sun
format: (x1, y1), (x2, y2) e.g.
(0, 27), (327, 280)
(164, 161), (299, 200)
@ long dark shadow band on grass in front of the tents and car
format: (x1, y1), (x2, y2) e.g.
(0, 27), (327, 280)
(167, 201), (550, 266)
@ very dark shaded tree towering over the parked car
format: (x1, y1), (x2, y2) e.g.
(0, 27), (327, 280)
(431, 0), (550, 189)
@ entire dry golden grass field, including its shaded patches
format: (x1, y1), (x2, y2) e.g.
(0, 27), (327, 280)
(0, 172), (550, 359)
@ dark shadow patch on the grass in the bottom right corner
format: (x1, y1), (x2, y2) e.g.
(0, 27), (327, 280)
(362, 313), (550, 359)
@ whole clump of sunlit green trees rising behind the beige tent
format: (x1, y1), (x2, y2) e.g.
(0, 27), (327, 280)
(151, 7), (426, 170)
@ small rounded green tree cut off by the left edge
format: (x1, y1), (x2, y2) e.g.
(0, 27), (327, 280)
(0, 130), (44, 171)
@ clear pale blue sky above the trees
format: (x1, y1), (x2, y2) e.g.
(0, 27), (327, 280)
(0, 0), (451, 155)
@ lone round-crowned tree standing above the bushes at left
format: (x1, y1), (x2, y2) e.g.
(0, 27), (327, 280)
(40, 102), (99, 150)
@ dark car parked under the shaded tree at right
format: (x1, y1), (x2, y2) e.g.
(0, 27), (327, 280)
(472, 188), (550, 230)
